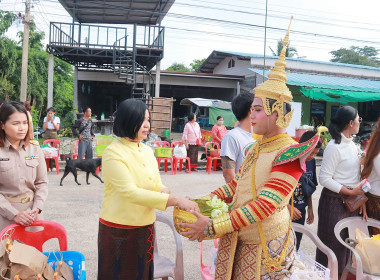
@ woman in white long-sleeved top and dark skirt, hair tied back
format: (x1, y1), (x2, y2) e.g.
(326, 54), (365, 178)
(316, 106), (365, 275)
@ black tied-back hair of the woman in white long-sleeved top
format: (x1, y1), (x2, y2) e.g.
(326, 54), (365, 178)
(329, 106), (358, 144)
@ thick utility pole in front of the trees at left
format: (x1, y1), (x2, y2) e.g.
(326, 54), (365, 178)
(20, 0), (31, 102)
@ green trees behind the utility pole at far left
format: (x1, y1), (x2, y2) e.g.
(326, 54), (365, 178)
(0, 6), (74, 127)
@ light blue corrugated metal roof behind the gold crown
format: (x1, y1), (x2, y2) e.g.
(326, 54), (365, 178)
(249, 68), (380, 93)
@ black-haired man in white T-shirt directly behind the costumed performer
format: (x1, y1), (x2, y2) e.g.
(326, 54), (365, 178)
(220, 93), (254, 183)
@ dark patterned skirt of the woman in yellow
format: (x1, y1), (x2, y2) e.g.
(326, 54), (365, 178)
(98, 222), (154, 280)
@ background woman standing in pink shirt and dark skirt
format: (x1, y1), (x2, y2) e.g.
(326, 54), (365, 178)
(182, 113), (202, 172)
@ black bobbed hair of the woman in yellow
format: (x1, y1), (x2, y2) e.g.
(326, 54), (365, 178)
(113, 99), (148, 139)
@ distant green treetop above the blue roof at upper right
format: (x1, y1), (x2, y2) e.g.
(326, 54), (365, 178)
(330, 46), (380, 67)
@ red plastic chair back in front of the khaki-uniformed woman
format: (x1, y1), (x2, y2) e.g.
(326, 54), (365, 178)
(0, 221), (67, 252)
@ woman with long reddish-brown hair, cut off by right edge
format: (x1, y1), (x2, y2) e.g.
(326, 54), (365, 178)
(361, 118), (380, 235)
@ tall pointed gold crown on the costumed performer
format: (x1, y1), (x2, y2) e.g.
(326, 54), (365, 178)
(253, 17), (293, 128)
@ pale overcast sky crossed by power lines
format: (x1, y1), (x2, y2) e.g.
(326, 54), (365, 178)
(0, 0), (380, 69)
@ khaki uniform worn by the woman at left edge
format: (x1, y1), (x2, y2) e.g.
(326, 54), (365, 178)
(0, 139), (48, 230)
